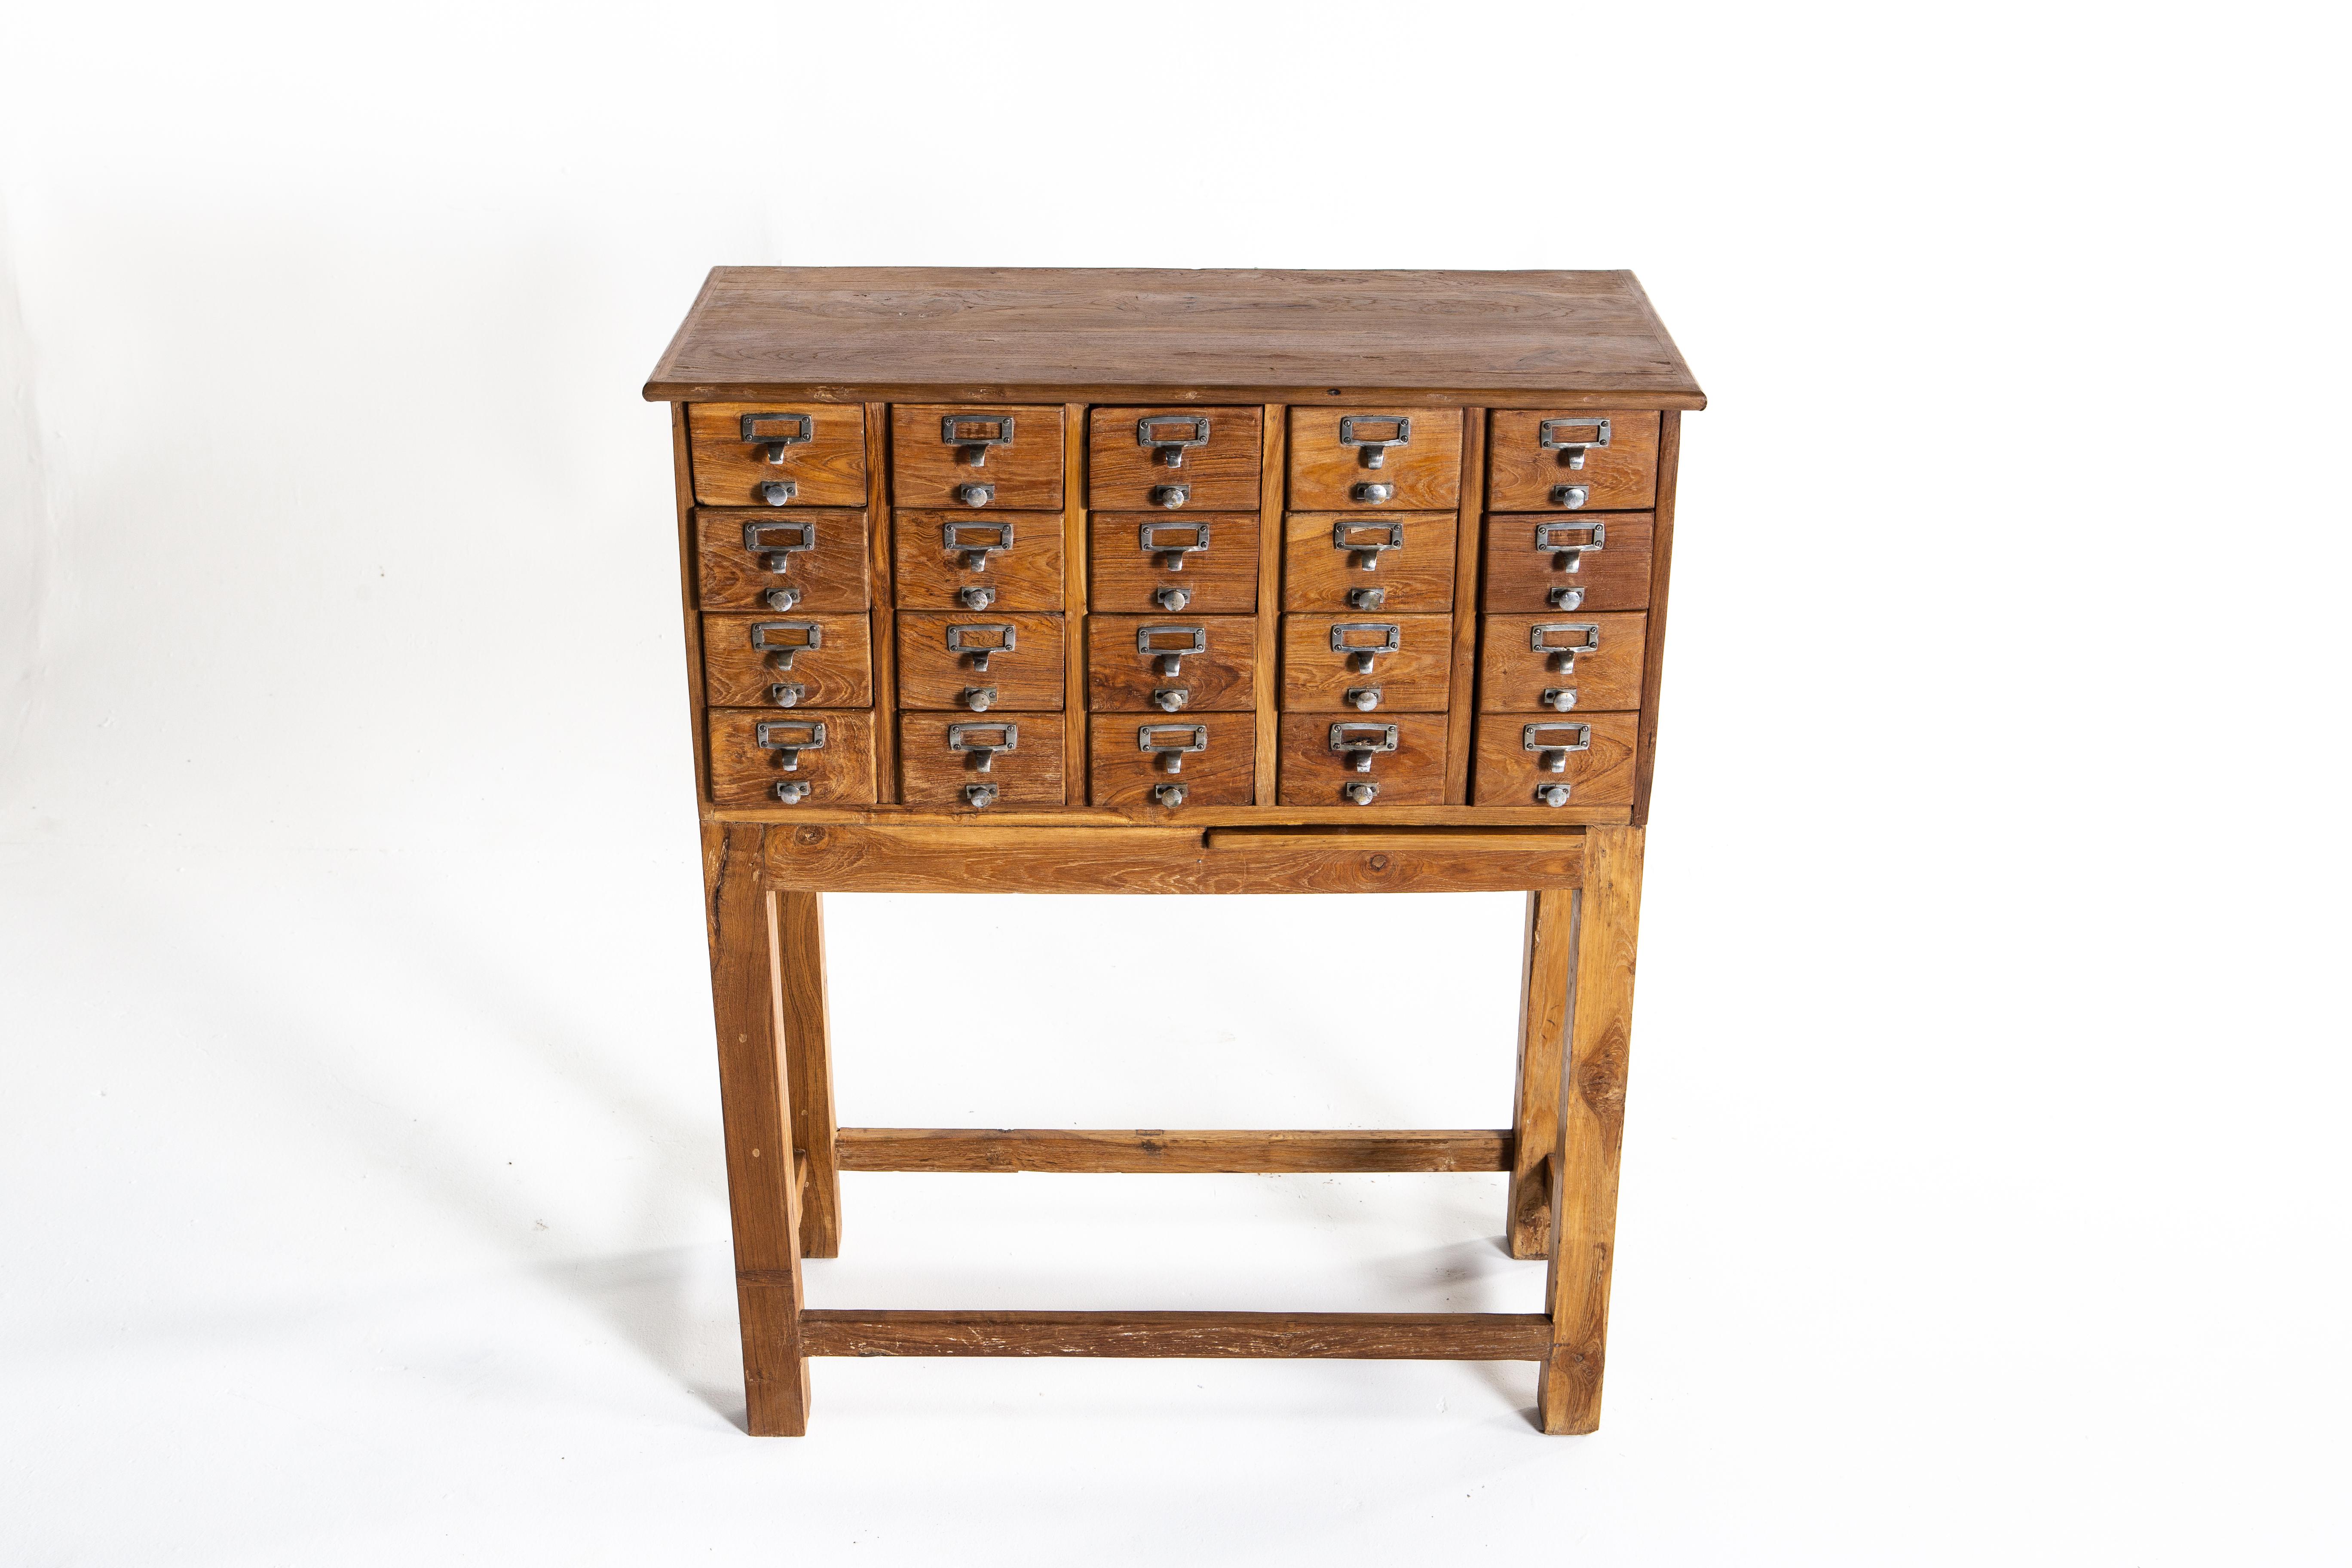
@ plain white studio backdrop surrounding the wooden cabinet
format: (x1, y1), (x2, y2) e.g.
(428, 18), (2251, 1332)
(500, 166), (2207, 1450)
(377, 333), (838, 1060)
(0, 0), (2352, 1563)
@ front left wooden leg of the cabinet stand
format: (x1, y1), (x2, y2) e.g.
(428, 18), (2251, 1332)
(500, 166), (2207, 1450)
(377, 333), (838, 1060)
(703, 823), (809, 1436)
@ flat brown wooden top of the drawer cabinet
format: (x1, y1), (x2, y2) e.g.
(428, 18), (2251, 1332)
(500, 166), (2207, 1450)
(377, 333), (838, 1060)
(644, 266), (1708, 409)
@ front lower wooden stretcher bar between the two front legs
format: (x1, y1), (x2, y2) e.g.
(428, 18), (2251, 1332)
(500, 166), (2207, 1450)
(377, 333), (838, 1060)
(802, 1309), (1550, 1361)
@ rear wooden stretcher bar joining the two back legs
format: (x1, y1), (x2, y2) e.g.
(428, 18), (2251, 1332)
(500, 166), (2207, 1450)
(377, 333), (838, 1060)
(840, 1128), (1514, 1176)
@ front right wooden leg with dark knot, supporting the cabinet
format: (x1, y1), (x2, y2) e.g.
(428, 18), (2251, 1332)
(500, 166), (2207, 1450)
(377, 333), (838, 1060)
(1536, 827), (1642, 1432)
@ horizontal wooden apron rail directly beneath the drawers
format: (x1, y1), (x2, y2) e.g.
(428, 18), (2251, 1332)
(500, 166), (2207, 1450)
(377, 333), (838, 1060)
(769, 823), (1583, 893)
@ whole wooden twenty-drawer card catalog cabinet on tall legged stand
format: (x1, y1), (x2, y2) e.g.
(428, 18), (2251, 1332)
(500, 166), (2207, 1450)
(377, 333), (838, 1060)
(644, 268), (1705, 1434)
